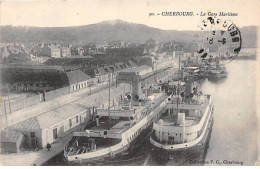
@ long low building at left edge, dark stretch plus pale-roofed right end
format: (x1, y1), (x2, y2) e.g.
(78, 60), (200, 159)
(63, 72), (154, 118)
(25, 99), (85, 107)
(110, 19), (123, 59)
(1, 64), (95, 92)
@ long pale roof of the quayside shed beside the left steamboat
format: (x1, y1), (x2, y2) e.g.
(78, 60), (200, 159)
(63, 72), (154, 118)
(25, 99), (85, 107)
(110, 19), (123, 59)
(8, 84), (130, 131)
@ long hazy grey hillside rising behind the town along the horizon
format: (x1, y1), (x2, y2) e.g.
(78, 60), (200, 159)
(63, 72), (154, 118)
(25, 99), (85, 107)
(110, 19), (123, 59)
(0, 20), (257, 47)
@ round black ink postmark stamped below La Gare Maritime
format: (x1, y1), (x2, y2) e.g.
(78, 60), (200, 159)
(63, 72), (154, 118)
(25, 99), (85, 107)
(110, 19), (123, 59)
(196, 17), (242, 64)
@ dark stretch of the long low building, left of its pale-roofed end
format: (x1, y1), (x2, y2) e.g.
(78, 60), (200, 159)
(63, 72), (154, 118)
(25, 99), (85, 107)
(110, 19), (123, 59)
(1, 64), (67, 91)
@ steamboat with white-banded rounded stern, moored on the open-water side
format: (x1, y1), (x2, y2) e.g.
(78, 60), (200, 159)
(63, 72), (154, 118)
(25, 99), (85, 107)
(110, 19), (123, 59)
(150, 76), (214, 164)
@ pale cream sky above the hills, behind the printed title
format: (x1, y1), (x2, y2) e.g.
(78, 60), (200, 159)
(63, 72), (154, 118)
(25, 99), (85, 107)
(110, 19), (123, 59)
(0, 0), (260, 30)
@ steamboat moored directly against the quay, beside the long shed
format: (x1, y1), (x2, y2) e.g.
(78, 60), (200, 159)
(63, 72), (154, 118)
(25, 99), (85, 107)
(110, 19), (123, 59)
(64, 84), (169, 164)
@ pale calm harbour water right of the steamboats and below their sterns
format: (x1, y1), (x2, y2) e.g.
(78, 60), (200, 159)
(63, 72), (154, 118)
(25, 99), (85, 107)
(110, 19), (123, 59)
(44, 60), (257, 165)
